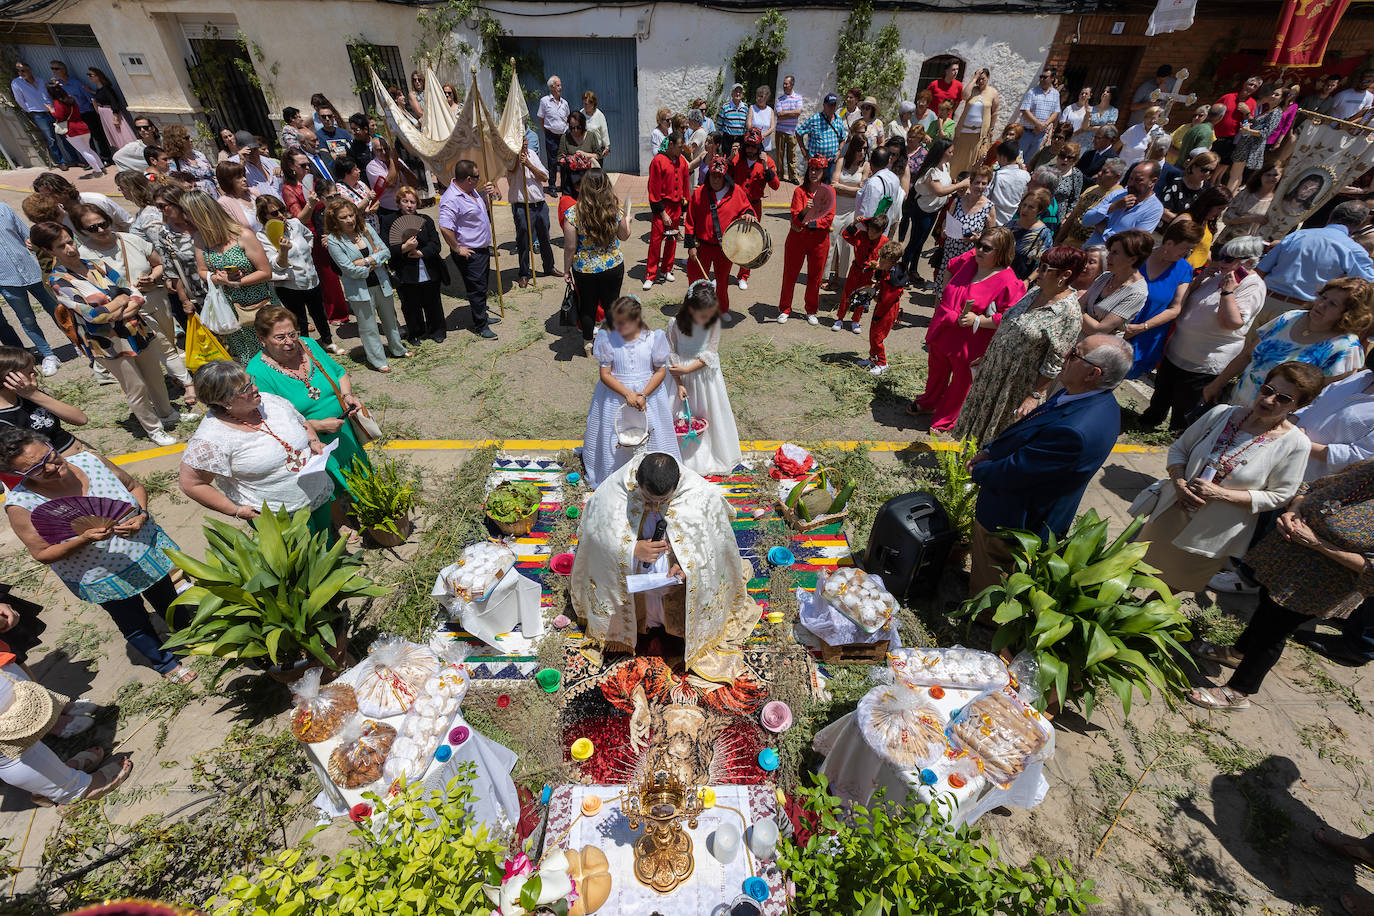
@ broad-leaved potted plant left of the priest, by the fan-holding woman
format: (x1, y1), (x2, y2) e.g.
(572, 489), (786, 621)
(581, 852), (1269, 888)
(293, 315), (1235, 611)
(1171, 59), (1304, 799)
(166, 505), (386, 681)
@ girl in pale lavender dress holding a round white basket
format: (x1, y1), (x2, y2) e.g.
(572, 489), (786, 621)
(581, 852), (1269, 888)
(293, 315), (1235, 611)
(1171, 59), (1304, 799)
(583, 295), (682, 489)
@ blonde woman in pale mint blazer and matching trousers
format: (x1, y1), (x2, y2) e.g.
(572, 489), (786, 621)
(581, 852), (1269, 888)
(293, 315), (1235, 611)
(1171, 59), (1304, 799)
(324, 198), (411, 372)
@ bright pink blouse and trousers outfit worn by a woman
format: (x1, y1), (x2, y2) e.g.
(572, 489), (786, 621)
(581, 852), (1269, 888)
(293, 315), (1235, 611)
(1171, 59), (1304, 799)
(915, 251), (1026, 430)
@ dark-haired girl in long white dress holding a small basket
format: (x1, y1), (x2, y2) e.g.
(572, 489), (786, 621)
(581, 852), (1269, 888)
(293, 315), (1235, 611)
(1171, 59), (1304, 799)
(668, 280), (743, 475)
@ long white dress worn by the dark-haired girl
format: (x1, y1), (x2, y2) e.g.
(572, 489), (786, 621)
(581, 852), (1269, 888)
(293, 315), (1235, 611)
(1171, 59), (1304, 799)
(668, 321), (743, 475)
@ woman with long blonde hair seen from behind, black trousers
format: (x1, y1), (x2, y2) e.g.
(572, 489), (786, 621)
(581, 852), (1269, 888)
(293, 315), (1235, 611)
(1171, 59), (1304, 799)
(563, 169), (629, 356)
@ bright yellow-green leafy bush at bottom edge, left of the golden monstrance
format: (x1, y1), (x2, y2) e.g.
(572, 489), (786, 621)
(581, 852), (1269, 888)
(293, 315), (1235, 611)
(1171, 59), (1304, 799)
(213, 764), (502, 916)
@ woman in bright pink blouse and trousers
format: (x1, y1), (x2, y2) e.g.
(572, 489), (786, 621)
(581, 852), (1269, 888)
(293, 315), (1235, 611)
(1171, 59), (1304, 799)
(907, 225), (1026, 433)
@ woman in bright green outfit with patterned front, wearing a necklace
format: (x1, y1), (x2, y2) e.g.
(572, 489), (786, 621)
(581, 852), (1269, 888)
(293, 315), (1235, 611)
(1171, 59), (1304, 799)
(247, 305), (371, 494)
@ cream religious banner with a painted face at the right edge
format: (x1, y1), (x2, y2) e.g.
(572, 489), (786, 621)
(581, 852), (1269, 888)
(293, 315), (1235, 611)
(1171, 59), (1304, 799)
(1264, 110), (1374, 239)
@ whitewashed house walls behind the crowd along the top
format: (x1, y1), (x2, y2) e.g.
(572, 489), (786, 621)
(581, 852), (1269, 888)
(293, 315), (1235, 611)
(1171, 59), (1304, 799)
(26, 0), (1058, 172)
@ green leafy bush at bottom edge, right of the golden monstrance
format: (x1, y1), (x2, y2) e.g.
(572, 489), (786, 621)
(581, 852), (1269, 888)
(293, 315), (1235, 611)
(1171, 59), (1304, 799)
(778, 776), (1101, 916)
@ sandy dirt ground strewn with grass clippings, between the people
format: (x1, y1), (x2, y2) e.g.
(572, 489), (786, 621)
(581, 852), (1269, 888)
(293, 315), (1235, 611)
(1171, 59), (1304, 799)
(0, 174), (1374, 916)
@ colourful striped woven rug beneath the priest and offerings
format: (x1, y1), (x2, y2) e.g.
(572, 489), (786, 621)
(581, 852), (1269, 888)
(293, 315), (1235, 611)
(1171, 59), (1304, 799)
(441, 456), (851, 680)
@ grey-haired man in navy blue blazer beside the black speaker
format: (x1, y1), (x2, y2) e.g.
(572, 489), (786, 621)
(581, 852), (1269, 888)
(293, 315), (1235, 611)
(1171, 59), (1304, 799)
(969, 334), (1134, 595)
